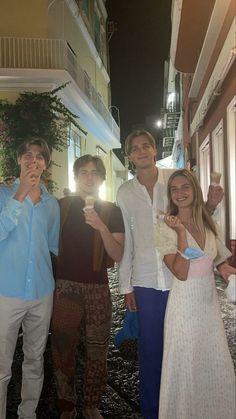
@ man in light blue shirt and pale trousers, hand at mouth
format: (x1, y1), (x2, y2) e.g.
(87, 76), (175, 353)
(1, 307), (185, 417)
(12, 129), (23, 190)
(0, 138), (59, 419)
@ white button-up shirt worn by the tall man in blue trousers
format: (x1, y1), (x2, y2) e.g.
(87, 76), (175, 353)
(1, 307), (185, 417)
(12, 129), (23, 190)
(117, 169), (175, 294)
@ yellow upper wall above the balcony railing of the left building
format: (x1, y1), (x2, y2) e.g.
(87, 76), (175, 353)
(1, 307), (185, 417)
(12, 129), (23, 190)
(0, 0), (109, 106)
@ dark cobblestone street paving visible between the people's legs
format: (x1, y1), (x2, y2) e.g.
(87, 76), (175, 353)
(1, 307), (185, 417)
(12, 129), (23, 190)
(7, 269), (236, 419)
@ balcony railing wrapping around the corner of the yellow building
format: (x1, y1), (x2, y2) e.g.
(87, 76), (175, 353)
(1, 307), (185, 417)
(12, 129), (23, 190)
(0, 37), (120, 138)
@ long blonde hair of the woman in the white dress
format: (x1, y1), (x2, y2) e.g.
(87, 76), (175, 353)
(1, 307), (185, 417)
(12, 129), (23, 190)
(167, 169), (217, 236)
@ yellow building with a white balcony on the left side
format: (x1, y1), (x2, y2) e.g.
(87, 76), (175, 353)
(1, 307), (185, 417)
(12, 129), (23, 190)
(0, 0), (124, 201)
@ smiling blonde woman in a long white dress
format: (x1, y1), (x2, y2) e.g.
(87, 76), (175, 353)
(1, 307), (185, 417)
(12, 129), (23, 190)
(156, 169), (236, 419)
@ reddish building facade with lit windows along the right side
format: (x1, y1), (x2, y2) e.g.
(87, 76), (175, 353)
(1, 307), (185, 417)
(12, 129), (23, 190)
(166, 0), (236, 266)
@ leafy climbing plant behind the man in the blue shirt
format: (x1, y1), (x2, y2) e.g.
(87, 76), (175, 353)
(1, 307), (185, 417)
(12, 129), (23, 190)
(0, 83), (86, 191)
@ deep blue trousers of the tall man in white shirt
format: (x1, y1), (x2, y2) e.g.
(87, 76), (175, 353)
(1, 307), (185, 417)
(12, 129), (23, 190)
(134, 287), (169, 419)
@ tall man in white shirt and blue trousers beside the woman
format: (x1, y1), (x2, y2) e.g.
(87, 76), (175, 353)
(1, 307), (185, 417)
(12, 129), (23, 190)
(117, 131), (226, 419)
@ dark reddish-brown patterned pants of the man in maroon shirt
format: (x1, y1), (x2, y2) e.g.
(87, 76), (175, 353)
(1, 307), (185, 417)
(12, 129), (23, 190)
(52, 279), (112, 411)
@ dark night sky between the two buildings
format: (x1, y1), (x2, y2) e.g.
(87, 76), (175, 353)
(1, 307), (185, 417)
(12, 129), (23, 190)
(106, 0), (171, 141)
